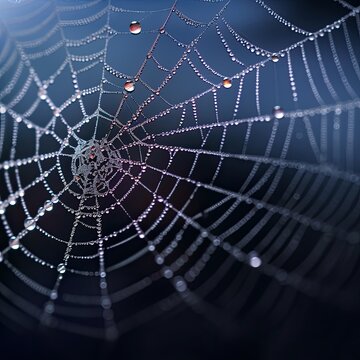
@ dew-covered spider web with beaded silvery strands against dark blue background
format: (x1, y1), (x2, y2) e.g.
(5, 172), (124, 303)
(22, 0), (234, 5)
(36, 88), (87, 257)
(0, 0), (360, 339)
